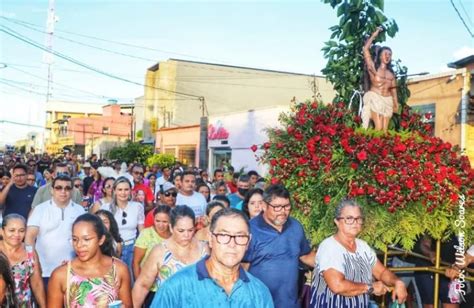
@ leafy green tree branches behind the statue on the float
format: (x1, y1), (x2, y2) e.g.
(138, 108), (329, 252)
(322, 0), (402, 109)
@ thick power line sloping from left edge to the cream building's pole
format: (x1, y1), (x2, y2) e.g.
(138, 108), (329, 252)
(1, 25), (201, 100)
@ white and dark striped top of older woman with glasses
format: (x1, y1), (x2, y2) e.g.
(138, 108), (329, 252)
(310, 236), (377, 308)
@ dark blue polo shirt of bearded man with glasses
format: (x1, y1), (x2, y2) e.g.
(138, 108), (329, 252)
(242, 213), (311, 308)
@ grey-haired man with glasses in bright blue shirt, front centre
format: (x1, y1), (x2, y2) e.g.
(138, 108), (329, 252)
(151, 208), (274, 308)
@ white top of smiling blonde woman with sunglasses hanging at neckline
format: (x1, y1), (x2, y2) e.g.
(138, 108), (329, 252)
(100, 201), (145, 241)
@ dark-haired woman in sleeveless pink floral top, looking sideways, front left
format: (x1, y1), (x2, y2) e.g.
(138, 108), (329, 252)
(48, 214), (132, 308)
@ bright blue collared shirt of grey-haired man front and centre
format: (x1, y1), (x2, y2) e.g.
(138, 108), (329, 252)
(151, 257), (274, 308)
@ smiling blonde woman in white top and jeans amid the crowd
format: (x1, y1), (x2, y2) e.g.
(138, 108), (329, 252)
(100, 177), (145, 270)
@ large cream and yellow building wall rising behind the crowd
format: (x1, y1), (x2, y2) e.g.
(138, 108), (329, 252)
(144, 59), (335, 141)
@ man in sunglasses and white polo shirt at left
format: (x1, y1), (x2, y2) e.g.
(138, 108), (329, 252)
(25, 175), (85, 288)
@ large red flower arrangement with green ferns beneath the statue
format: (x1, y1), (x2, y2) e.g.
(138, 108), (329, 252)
(260, 102), (474, 249)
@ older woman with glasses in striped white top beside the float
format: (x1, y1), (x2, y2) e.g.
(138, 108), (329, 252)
(309, 199), (407, 308)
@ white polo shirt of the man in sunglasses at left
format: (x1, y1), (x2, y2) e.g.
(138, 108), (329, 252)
(28, 200), (86, 277)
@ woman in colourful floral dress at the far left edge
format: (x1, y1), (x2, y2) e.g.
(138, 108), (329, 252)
(0, 214), (46, 308)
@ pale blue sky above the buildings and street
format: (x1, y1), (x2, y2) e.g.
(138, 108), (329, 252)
(0, 0), (474, 145)
